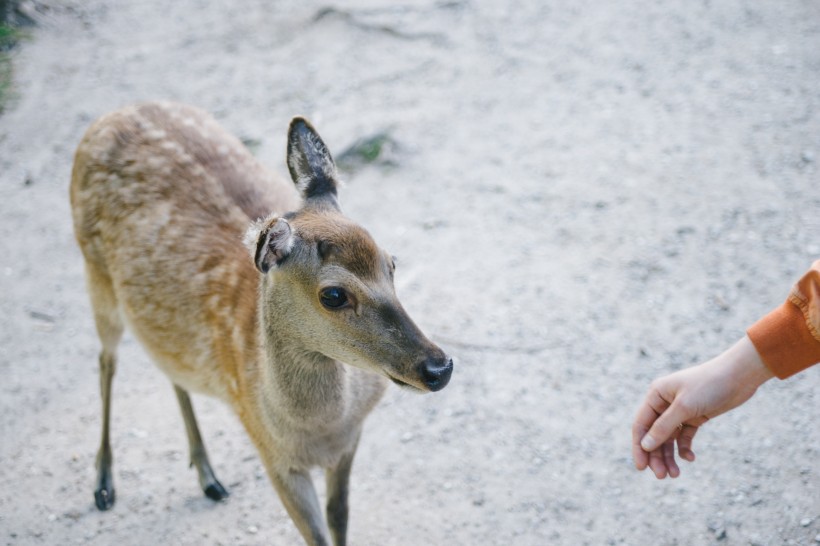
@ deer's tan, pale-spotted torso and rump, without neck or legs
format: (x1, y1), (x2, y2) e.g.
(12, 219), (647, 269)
(71, 103), (300, 398)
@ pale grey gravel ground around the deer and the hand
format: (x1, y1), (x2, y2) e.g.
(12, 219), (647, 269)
(0, 0), (820, 546)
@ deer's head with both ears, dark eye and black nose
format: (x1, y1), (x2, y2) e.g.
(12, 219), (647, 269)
(246, 118), (453, 392)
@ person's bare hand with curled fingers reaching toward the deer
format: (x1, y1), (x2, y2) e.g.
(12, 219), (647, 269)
(632, 336), (773, 479)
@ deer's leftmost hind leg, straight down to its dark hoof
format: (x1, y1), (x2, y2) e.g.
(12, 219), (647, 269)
(86, 265), (123, 510)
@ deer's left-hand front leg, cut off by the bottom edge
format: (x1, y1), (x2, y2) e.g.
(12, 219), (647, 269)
(268, 466), (330, 546)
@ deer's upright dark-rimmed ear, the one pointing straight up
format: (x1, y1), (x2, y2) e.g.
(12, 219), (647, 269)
(287, 117), (339, 208)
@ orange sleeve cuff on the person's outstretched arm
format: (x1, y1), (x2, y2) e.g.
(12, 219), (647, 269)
(746, 260), (820, 379)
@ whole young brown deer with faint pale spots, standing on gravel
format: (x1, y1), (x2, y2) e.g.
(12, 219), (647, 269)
(71, 103), (453, 545)
